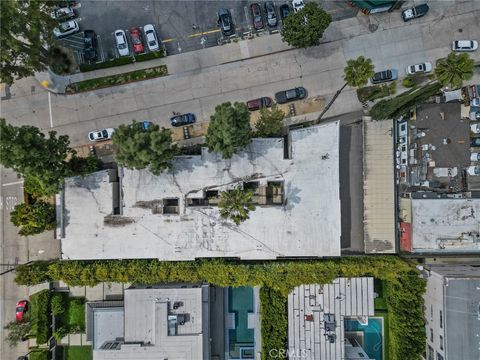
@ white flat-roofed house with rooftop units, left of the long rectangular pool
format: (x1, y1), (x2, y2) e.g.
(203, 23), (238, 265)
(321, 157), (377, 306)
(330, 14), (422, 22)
(93, 285), (210, 360)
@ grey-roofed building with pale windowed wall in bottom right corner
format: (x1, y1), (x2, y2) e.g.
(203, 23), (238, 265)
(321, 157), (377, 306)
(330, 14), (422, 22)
(424, 265), (480, 360)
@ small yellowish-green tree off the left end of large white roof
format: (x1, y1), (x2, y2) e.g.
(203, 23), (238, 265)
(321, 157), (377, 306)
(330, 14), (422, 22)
(10, 200), (56, 236)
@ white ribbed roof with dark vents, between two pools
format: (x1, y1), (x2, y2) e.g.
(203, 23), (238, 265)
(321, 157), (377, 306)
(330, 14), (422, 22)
(288, 277), (374, 360)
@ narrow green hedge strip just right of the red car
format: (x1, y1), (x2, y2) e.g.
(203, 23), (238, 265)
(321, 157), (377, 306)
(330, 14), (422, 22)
(30, 290), (52, 344)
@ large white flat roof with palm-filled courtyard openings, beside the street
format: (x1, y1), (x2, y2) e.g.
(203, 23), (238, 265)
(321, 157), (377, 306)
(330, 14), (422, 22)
(59, 122), (341, 261)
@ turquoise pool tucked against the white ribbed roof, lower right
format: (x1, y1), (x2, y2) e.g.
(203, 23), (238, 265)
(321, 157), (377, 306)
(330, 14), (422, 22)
(344, 317), (383, 360)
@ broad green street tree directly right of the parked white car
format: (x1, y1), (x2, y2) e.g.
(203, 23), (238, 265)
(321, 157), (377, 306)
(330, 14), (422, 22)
(112, 121), (177, 175)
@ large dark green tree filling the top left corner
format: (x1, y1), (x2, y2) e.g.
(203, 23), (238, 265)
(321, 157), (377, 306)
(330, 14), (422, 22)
(0, 0), (58, 85)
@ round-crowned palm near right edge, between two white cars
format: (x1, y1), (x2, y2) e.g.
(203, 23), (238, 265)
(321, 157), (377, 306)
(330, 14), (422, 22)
(435, 52), (475, 89)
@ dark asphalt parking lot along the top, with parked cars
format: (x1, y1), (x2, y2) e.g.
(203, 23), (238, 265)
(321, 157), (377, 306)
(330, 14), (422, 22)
(60, 0), (358, 62)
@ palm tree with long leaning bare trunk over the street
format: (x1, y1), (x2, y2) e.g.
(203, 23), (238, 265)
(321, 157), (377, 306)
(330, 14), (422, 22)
(316, 56), (375, 124)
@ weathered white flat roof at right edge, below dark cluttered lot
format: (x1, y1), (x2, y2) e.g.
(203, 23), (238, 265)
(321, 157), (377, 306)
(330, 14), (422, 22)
(412, 199), (480, 253)
